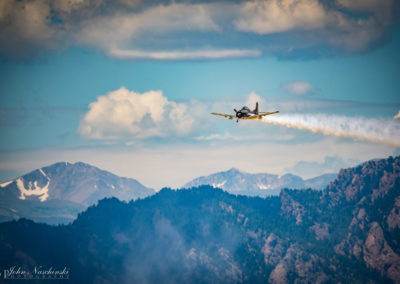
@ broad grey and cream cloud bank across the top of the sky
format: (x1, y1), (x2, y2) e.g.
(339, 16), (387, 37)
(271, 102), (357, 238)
(0, 0), (399, 60)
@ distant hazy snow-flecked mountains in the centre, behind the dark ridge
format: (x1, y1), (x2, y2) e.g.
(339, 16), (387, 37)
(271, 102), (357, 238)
(183, 168), (337, 197)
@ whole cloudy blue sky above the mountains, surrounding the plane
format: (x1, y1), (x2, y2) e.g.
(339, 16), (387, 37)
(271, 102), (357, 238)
(0, 0), (400, 190)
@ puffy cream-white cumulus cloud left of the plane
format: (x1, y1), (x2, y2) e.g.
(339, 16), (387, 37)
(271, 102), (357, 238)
(78, 87), (196, 140)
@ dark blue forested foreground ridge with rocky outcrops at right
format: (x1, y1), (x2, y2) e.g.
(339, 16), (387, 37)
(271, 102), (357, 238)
(0, 157), (400, 283)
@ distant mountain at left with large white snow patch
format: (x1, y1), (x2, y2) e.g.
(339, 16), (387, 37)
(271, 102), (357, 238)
(0, 162), (154, 224)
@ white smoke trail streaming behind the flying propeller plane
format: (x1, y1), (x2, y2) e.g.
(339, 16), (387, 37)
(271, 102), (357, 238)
(263, 114), (400, 147)
